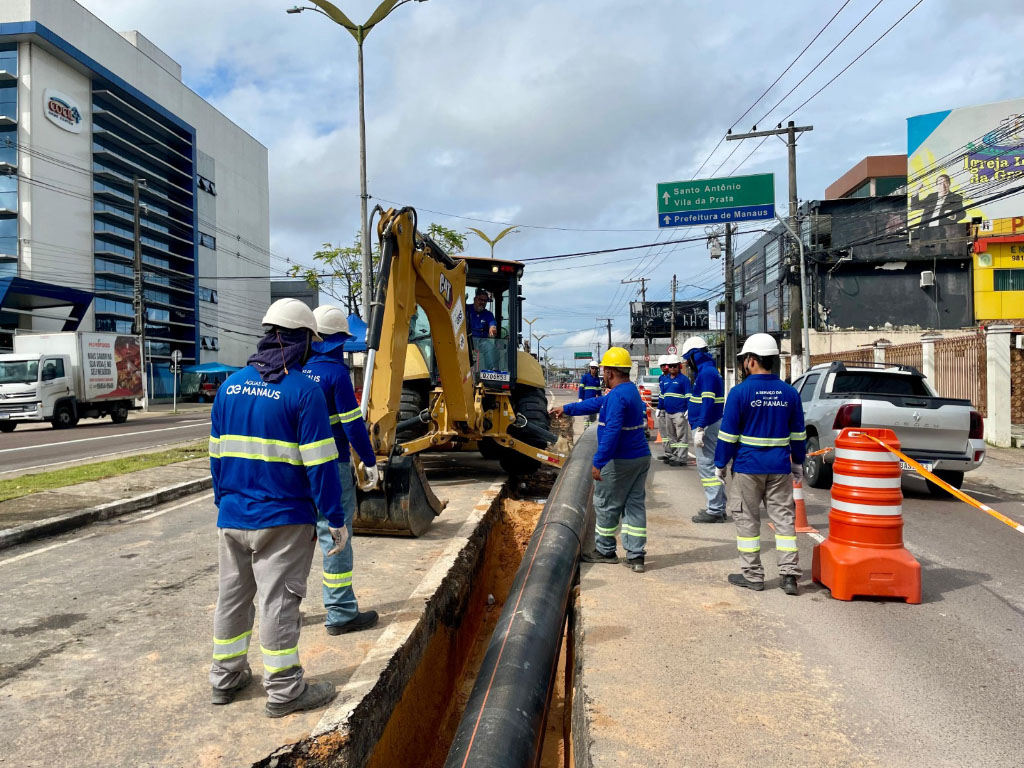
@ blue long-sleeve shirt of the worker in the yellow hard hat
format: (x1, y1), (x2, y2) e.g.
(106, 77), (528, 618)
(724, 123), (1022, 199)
(563, 381), (650, 469)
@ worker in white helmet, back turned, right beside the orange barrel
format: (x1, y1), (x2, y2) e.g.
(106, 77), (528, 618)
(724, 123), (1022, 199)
(715, 334), (807, 595)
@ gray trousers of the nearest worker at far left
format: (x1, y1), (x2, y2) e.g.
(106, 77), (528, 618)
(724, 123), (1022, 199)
(210, 524), (316, 703)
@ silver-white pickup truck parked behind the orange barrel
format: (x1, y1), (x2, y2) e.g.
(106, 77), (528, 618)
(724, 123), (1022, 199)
(794, 361), (985, 495)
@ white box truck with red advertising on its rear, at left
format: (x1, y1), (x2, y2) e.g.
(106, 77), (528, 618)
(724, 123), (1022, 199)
(0, 332), (143, 432)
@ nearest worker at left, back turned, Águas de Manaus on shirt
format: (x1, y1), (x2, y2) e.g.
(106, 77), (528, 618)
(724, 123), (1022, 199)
(210, 299), (351, 718)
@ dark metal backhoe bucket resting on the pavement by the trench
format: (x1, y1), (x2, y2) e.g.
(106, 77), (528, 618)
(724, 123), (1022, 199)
(352, 455), (447, 537)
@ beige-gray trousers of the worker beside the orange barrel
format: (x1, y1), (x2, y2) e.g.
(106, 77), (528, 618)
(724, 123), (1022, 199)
(729, 472), (801, 582)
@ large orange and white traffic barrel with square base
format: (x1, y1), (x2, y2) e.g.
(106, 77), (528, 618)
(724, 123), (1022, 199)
(811, 428), (921, 603)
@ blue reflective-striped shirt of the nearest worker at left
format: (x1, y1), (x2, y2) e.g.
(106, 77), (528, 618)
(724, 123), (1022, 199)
(210, 366), (351, 530)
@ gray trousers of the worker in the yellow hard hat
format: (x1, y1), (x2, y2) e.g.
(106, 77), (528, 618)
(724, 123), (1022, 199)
(594, 456), (650, 559)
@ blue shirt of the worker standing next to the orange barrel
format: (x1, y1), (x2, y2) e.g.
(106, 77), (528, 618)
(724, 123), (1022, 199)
(715, 374), (807, 475)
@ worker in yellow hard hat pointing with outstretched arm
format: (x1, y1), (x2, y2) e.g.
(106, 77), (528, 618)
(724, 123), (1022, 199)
(551, 347), (650, 573)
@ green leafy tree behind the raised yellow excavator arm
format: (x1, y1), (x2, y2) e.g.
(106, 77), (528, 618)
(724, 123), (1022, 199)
(289, 223), (466, 314)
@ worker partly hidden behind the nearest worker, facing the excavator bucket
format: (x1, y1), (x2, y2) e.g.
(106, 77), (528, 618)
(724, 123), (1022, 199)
(302, 306), (379, 635)
